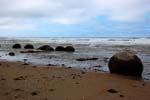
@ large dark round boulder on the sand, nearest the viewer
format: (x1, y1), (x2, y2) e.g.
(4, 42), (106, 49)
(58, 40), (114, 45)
(108, 51), (143, 77)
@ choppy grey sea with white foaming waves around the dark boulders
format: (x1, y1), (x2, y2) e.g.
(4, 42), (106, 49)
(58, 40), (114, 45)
(0, 38), (150, 79)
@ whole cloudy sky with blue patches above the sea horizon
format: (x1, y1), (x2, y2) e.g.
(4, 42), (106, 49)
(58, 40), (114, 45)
(0, 0), (150, 37)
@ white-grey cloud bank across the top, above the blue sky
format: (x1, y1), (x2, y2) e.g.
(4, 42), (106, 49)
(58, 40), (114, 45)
(0, 0), (150, 24)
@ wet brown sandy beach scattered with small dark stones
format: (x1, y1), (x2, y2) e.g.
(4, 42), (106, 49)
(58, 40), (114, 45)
(0, 61), (150, 100)
